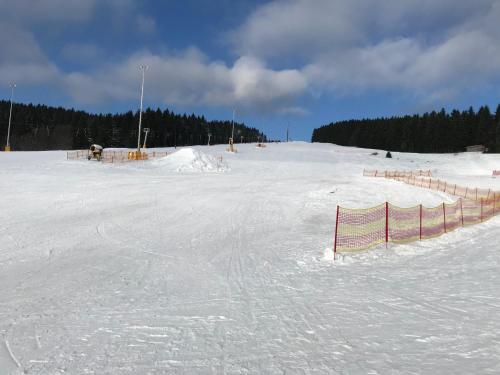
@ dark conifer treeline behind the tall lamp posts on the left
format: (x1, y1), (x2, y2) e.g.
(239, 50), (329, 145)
(0, 101), (266, 151)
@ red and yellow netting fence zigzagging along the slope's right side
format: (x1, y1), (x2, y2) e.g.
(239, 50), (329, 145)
(334, 171), (500, 253)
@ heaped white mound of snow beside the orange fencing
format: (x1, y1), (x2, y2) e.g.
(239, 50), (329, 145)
(153, 147), (229, 172)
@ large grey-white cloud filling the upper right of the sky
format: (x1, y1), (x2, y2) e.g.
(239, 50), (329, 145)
(229, 0), (500, 101)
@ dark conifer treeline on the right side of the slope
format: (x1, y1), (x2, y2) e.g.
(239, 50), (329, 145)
(312, 105), (500, 153)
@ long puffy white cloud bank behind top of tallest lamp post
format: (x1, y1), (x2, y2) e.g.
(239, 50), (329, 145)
(65, 48), (307, 111)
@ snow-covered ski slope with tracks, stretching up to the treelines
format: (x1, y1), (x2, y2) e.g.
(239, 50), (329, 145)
(0, 143), (500, 374)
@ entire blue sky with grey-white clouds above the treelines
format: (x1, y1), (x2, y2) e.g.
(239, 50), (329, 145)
(0, 0), (500, 140)
